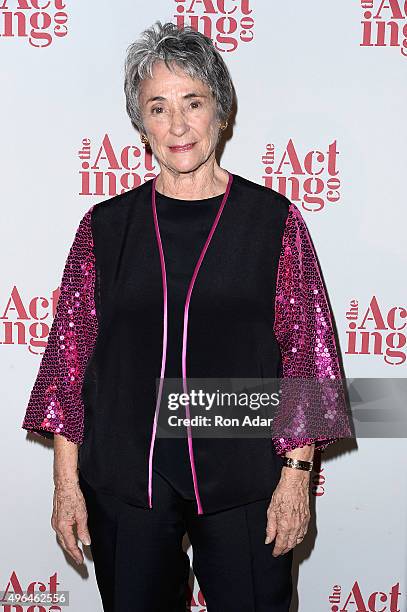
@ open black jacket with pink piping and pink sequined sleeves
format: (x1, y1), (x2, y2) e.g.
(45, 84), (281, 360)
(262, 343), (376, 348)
(22, 174), (350, 513)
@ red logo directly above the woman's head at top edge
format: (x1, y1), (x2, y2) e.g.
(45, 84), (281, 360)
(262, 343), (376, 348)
(174, 0), (254, 53)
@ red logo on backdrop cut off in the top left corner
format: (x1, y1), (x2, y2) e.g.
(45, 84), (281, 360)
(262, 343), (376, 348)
(0, 0), (68, 48)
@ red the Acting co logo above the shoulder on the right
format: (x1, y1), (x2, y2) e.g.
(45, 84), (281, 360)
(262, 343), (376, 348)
(261, 138), (341, 212)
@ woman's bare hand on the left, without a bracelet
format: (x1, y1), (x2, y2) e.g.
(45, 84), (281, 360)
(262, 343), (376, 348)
(51, 481), (91, 565)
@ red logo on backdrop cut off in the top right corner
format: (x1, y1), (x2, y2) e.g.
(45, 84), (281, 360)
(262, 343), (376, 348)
(360, 0), (407, 57)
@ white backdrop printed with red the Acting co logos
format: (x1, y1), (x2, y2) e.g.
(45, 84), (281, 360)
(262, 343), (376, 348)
(0, 0), (407, 612)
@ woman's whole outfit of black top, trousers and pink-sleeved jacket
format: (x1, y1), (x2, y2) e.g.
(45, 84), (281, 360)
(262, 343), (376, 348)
(22, 174), (351, 612)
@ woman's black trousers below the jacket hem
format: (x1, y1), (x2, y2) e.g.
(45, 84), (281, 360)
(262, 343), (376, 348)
(79, 473), (293, 612)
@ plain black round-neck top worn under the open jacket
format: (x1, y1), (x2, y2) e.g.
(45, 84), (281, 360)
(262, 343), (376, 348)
(153, 191), (223, 500)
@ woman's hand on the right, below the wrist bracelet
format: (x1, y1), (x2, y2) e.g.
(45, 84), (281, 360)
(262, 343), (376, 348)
(265, 466), (311, 557)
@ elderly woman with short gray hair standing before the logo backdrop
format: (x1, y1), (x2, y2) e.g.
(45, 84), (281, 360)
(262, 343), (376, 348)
(22, 22), (350, 612)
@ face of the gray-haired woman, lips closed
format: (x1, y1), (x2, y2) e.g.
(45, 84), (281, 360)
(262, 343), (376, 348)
(139, 61), (223, 174)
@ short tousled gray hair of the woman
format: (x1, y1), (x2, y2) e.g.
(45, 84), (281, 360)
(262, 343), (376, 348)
(124, 21), (234, 131)
